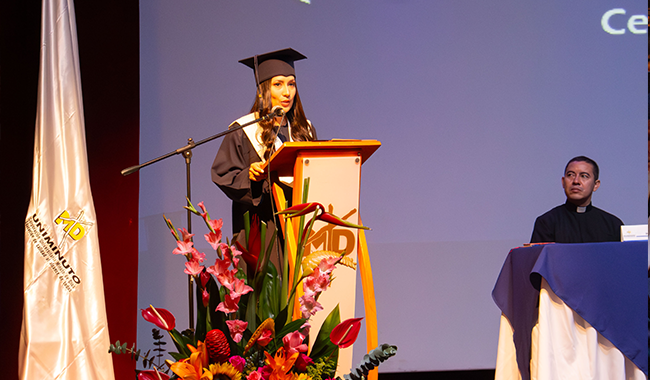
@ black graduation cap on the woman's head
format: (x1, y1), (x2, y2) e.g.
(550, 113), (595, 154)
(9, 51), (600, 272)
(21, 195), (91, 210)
(239, 48), (307, 84)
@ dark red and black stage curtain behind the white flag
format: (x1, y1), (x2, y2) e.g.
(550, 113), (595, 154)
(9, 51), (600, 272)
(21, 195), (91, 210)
(0, 0), (139, 379)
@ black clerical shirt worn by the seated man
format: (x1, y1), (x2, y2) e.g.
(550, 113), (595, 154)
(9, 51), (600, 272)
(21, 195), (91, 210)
(530, 201), (623, 243)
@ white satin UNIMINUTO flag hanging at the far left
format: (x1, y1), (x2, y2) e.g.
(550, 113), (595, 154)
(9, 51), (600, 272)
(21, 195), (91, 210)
(19, 0), (115, 380)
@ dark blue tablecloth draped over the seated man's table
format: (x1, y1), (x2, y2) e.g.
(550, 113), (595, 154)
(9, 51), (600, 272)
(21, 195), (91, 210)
(492, 241), (648, 380)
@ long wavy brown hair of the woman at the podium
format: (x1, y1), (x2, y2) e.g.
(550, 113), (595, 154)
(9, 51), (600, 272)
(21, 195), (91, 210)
(251, 78), (316, 159)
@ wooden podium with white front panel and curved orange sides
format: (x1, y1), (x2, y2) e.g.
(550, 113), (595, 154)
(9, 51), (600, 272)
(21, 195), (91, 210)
(267, 140), (381, 379)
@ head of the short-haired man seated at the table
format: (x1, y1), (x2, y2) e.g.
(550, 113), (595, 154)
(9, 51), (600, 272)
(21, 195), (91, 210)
(562, 161), (600, 207)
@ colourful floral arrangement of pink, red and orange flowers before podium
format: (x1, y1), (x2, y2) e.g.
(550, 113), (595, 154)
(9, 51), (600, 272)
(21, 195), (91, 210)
(109, 200), (397, 380)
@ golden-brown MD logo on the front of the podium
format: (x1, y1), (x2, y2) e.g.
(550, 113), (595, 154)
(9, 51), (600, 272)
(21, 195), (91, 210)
(307, 204), (357, 255)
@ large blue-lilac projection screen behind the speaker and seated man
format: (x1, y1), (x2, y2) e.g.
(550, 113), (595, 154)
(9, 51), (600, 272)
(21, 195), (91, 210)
(138, 0), (647, 372)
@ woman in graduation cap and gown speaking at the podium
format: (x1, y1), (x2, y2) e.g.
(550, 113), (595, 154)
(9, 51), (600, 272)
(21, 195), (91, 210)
(212, 48), (316, 243)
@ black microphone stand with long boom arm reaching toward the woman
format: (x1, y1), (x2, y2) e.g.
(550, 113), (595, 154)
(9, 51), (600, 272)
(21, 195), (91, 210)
(121, 110), (282, 330)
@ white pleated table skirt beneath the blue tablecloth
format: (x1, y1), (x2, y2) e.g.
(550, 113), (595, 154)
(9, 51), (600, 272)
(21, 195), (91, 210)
(495, 280), (647, 380)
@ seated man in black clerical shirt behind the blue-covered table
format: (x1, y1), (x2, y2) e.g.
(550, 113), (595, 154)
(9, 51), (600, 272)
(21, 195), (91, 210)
(530, 156), (623, 243)
